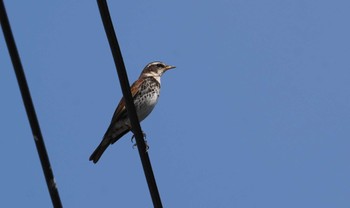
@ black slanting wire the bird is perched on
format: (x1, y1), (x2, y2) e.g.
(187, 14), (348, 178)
(97, 0), (163, 207)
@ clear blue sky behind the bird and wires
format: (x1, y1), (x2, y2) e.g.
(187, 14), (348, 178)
(0, 0), (350, 208)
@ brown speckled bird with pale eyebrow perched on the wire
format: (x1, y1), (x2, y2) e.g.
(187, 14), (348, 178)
(89, 61), (175, 163)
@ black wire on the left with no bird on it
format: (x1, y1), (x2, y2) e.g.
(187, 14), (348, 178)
(0, 0), (62, 208)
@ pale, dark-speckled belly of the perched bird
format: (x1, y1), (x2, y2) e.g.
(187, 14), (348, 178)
(135, 92), (159, 121)
